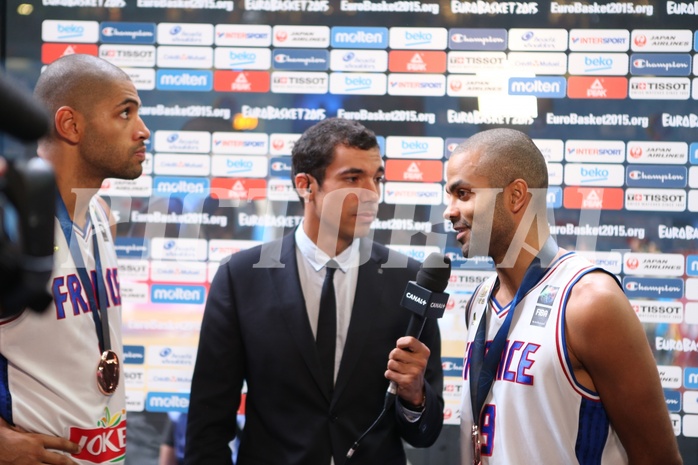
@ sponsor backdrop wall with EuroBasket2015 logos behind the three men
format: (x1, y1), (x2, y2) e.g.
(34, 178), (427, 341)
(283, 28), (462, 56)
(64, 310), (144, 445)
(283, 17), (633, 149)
(1, 0), (698, 463)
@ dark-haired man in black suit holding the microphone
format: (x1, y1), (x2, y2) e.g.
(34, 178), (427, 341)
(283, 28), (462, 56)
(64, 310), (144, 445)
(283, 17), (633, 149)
(185, 119), (443, 465)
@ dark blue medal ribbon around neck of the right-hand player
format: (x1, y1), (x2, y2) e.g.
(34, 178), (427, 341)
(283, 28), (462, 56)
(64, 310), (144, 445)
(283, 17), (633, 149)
(469, 236), (558, 450)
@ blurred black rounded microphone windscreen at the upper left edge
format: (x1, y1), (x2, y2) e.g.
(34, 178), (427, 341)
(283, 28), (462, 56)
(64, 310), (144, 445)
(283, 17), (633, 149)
(0, 74), (50, 142)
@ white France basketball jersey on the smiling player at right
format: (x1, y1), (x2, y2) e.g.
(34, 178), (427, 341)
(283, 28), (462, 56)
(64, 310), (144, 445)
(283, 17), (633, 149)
(461, 253), (628, 465)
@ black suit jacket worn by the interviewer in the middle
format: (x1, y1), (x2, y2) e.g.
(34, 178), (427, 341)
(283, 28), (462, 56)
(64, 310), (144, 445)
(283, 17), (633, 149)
(185, 234), (443, 465)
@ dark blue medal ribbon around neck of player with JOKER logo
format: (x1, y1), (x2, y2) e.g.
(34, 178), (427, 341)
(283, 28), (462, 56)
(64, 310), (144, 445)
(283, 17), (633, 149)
(56, 194), (111, 352)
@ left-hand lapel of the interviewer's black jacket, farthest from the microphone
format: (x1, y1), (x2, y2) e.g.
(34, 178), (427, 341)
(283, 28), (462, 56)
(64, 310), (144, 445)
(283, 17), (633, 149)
(269, 234), (331, 401)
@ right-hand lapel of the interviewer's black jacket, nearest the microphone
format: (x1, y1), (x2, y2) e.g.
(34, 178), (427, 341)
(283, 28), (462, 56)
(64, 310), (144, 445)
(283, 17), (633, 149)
(334, 240), (383, 399)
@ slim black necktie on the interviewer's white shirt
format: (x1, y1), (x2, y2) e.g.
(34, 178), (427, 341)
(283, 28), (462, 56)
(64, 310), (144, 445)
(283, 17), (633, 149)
(315, 260), (337, 391)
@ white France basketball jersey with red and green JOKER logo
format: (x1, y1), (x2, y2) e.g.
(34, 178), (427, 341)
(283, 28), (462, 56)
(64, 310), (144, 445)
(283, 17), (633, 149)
(0, 198), (126, 465)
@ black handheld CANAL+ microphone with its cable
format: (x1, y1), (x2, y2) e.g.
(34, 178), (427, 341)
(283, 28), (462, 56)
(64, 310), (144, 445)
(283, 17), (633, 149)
(345, 253), (451, 465)
